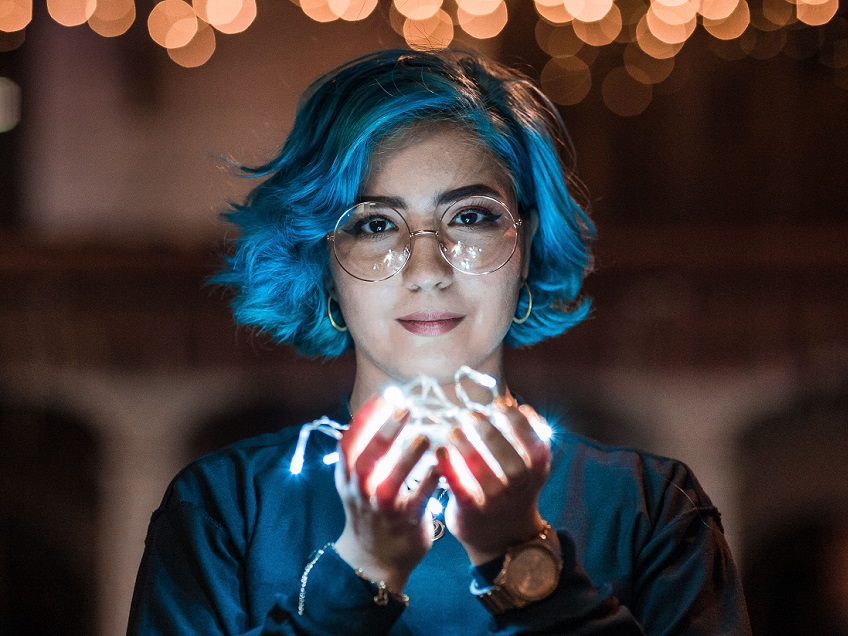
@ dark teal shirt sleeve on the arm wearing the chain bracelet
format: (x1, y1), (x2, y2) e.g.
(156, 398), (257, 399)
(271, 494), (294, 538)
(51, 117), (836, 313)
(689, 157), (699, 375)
(127, 484), (404, 636)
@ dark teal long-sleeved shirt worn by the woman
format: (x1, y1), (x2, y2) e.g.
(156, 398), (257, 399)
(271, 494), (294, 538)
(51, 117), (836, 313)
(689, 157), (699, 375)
(129, 420), (750, 636)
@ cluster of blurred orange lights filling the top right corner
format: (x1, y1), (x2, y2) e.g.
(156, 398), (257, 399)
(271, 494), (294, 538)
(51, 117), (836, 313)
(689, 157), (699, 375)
(533, 0), (848, 116)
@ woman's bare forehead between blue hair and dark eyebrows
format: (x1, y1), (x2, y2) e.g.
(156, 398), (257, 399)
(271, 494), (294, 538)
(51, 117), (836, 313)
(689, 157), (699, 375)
(362, 122), (514, 202)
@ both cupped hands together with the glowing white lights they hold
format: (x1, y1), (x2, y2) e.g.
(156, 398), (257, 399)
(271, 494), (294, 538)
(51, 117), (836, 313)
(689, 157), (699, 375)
(328, 369), (551, 591)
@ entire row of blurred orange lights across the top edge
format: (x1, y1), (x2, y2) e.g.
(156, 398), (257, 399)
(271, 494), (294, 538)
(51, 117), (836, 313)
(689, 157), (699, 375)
(0, 0), (848, 107)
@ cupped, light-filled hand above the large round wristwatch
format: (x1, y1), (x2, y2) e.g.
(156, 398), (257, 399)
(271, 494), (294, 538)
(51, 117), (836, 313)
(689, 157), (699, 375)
(436, 397), (551, 565)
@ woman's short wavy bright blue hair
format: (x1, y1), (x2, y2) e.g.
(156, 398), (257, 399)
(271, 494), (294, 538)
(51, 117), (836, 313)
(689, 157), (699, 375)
(211, 50), (594, 357)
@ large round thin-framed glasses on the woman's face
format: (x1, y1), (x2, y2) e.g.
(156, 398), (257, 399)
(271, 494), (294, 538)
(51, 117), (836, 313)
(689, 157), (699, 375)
(327, 196), (521, 282)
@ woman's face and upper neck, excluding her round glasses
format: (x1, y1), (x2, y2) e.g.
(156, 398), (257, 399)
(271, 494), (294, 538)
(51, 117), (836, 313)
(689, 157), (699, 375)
(331, 125), (527, 398)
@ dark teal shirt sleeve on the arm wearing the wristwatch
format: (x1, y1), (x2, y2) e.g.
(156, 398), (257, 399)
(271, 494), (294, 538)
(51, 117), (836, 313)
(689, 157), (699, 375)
(472, 463), (751, 636)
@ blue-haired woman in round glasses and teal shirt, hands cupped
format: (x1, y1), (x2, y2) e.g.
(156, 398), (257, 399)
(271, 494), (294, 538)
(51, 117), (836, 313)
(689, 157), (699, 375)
(130, 51), (749, 635)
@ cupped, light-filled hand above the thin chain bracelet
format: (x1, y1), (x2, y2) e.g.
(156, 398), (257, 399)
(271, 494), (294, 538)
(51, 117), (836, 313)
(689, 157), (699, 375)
(335, 396), (439, 593)
